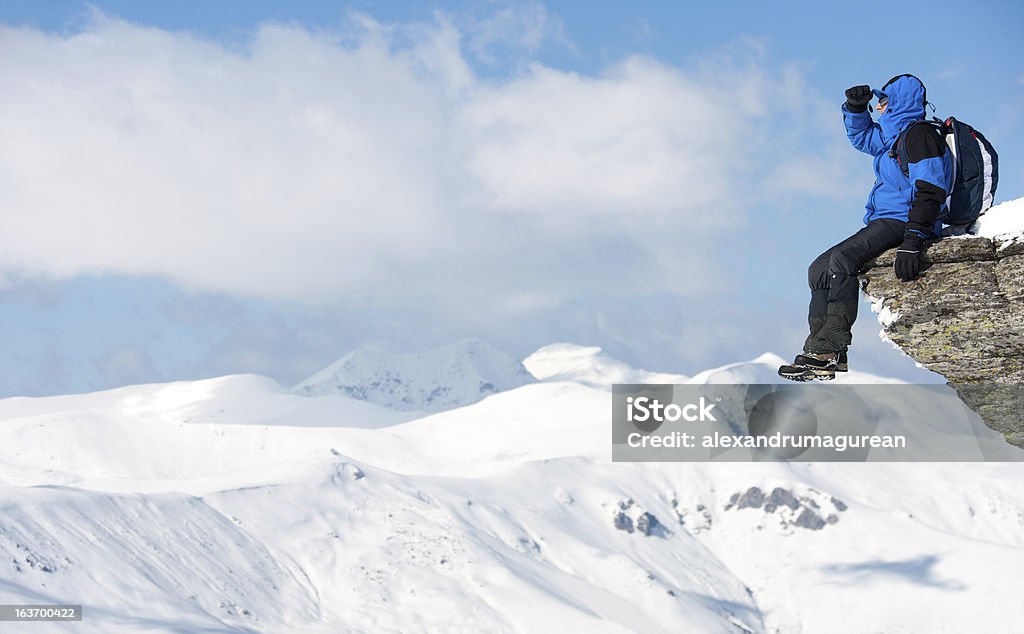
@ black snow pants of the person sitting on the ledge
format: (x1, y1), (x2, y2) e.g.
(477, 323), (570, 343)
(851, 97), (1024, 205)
(804, 218), (906, 353)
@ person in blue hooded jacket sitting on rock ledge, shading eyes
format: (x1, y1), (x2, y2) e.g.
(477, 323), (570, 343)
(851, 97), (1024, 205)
(778, 75), (952, 381)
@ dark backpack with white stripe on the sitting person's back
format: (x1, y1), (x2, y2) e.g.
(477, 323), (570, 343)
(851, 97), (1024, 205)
(893, 117), (999, 225)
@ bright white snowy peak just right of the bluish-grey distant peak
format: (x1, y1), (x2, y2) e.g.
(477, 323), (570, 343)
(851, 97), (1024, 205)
(522, 343), (688, 387)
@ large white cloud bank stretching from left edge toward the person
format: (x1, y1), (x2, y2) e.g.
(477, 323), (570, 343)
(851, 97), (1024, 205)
(0, 10), (847, 310)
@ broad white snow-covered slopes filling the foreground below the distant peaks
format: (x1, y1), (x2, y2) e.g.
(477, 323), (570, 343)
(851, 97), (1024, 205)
(0, 346), (1024, 634)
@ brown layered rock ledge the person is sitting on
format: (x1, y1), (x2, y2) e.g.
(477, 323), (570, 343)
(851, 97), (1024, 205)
(861, 236), (1024, 448)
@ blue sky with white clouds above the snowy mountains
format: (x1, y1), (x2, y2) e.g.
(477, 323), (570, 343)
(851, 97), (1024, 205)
(0, 0), (1024, 395)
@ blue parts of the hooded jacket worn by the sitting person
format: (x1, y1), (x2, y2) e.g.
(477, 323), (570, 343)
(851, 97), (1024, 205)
(843, 75), (952, 236)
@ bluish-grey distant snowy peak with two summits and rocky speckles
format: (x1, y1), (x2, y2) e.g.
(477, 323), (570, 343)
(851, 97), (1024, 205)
(292, 339), (534, 412)
